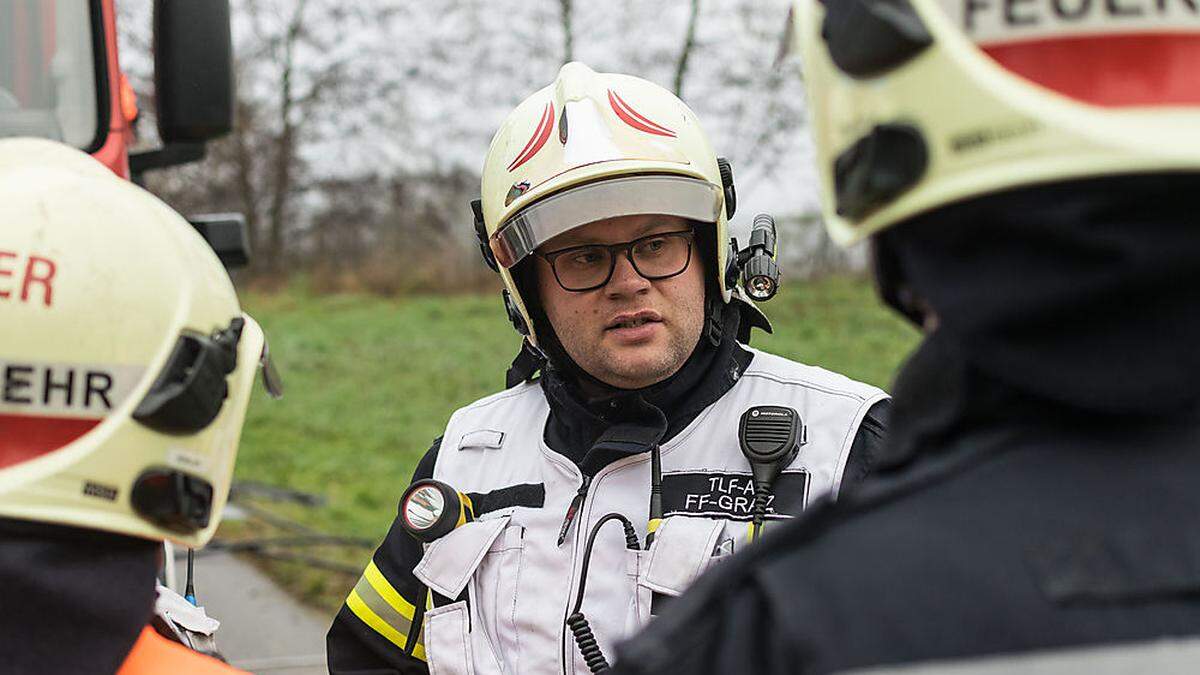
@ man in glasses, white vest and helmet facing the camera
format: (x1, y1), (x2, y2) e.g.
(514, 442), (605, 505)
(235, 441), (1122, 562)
(328, 62), (887, 674)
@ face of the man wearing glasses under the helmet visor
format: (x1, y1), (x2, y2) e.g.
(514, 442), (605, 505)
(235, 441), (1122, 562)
(535, 215), (704, 389)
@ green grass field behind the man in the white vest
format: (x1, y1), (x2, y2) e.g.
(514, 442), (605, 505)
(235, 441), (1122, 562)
(226, 277), (917, 605)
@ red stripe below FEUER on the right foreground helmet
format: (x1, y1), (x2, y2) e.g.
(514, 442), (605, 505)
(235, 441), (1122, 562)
(983, 32), (1200, 108)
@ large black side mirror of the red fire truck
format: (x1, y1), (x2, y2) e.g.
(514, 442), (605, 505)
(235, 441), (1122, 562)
(154, 0), (234, 145)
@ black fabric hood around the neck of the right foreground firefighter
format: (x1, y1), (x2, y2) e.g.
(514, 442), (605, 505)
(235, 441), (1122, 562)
(876, 174), (1200, 418)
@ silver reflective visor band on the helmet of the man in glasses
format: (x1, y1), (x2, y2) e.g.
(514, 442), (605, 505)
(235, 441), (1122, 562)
(492, 175), (721, 268)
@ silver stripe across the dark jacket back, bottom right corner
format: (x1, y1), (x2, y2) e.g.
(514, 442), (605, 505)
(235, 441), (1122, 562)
(841, 638), (1200, 675)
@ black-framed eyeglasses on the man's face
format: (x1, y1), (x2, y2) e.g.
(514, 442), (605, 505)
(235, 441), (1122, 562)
(536, 229), (694, 293)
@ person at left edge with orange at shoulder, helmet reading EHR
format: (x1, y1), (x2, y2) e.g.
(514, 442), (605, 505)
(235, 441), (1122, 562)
(0, 139), (276, 675)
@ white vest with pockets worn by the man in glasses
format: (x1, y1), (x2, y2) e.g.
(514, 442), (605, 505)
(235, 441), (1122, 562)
(413, 351), (887, 675)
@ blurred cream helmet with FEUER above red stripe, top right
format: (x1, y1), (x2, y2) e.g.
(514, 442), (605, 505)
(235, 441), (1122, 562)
(793, 0), (1200, 244)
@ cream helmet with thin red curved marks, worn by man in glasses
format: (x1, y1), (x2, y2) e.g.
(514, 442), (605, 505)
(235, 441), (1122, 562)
(473, 62), (734, 345)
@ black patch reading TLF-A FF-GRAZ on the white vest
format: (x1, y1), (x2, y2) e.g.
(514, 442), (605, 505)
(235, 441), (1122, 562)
(662, 471), (809, 521)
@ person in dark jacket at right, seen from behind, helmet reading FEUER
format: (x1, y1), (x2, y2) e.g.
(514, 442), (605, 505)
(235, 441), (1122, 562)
(613, 0), (1200, 674)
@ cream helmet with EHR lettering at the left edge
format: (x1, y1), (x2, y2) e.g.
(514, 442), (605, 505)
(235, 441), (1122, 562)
(0, 139), (274, 546)
